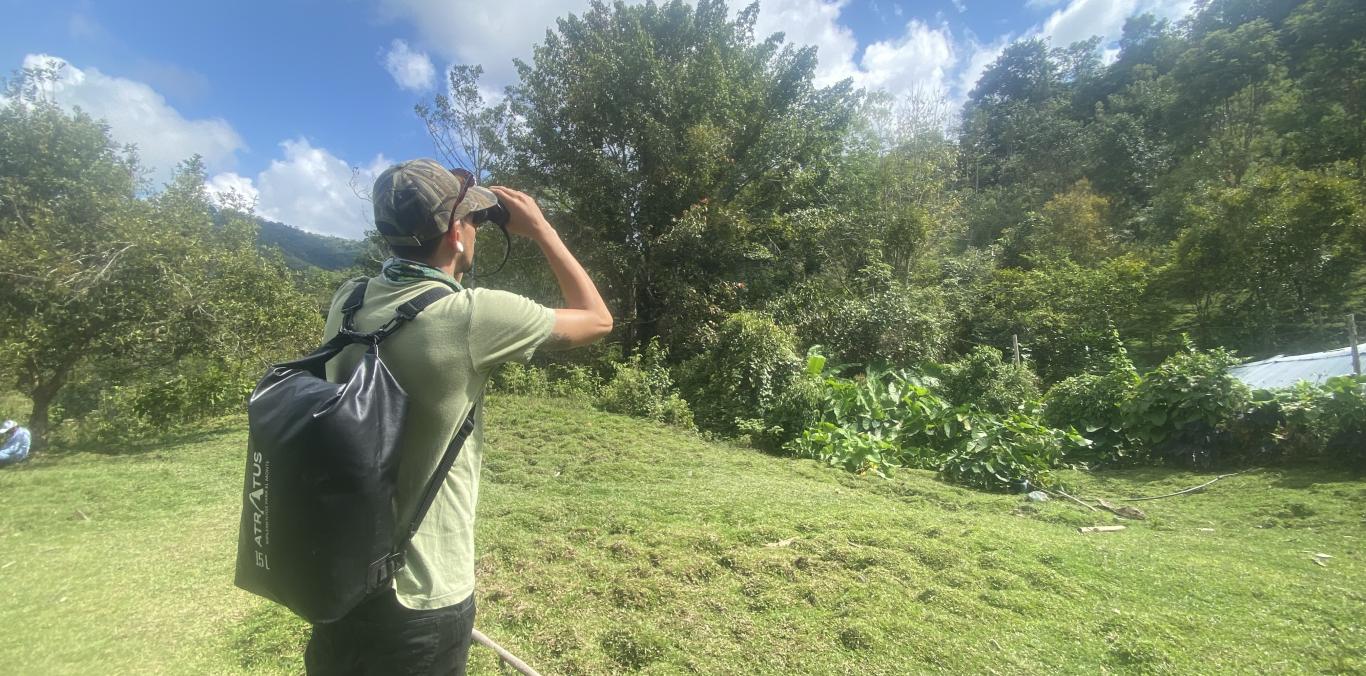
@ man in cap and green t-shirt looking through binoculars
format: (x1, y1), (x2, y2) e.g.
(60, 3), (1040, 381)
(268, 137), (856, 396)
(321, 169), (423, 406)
(305, 160), (612, 675)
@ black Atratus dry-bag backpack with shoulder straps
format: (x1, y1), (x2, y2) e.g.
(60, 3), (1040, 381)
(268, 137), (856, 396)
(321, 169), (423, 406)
(236, 280), (475, 624)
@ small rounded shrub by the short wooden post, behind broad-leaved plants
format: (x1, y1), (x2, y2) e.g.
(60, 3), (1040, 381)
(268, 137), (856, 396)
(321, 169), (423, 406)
(940, 346), (1040, 414)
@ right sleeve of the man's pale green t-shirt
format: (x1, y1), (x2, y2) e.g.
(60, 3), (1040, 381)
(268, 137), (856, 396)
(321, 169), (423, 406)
(470, 288), (555, 373)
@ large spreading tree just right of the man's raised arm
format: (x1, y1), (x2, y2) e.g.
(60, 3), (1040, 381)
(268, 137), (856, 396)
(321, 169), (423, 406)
(510, 0), (855, 355)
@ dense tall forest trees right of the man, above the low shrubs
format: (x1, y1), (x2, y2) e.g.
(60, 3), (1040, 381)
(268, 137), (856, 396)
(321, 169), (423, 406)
(419, 0), (1366, 382)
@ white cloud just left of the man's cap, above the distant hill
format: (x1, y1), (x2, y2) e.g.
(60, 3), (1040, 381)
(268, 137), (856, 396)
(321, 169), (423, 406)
(208, 138), (392, 239)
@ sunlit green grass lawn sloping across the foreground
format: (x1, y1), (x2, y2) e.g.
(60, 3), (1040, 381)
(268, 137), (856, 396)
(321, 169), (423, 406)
(0, 397), (1366, 675)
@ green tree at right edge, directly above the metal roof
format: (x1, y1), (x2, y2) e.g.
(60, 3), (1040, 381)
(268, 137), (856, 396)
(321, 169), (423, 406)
(1168, 165), (1366, 355)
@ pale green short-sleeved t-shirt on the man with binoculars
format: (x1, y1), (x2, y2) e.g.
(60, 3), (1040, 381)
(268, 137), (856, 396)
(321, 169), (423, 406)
(324, 276), (555, 609)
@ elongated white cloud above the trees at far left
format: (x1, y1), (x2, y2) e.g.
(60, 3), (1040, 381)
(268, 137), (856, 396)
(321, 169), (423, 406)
(23, 55), (243, 183)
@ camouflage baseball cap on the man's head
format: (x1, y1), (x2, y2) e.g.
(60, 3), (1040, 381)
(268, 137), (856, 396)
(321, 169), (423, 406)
(370, 158), (499, 246)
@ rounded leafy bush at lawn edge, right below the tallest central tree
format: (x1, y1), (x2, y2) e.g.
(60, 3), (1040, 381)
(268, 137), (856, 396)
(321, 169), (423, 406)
(678, 311), (802, 445)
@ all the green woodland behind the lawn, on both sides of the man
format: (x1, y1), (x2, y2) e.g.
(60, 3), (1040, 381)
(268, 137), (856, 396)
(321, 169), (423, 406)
(0, 0), (1366, 475)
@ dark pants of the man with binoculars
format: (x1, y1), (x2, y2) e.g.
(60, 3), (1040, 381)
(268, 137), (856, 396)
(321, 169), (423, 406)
(303, 590), (474, 676)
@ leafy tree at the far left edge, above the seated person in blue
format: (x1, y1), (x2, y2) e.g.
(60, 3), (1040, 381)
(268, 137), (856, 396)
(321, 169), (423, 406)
(0, 83), (146, 448)
